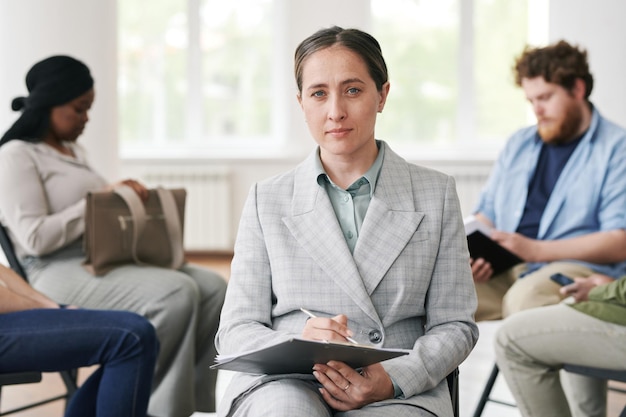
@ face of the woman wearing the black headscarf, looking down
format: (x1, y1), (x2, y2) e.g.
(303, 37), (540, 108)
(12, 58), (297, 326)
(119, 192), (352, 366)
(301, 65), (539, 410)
(50, 88), (95, 142)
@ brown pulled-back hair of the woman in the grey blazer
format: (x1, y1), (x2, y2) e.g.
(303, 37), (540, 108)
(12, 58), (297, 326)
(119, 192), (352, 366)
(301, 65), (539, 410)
(294, 26), (389, 93)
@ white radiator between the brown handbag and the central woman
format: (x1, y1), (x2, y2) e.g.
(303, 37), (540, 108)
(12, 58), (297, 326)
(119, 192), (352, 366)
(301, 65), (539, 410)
(140, 165), (234, 251)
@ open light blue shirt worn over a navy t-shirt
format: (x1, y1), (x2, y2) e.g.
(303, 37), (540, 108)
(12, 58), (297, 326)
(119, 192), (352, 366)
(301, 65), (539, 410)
(475, 108), (626, 278)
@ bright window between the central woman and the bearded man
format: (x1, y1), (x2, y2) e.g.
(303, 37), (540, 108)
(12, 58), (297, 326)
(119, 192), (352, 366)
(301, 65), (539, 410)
(372, 0), (540, 151)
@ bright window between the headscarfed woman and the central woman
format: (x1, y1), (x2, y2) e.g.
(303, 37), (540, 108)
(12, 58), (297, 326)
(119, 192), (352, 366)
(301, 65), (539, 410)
(119, 0), (273, 152)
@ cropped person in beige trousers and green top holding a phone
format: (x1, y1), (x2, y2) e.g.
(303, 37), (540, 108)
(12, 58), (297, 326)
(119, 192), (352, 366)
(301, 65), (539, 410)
(495, 274), (626, 417)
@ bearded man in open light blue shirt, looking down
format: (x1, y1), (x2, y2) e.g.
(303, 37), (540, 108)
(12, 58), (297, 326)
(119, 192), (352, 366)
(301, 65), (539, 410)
(471, 41), (626, 321)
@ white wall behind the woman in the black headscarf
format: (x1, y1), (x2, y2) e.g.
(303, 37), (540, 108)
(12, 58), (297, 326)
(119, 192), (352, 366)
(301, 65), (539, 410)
(0, 0), (119, 178)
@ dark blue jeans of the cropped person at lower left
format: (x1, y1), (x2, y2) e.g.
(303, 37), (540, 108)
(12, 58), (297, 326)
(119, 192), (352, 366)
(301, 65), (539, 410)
(0, 309), (158, 417)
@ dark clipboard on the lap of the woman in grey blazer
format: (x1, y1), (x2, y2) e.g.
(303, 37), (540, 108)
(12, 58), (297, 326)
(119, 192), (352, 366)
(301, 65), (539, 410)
(211, 337), (410, 374)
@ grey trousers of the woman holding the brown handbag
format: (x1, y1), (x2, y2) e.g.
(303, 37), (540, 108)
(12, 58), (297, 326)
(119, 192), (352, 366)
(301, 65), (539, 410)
(25, 247), (226, 417)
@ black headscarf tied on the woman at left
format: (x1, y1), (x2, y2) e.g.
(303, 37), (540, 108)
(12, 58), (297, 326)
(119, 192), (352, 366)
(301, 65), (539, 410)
(0, 55), (93, 146)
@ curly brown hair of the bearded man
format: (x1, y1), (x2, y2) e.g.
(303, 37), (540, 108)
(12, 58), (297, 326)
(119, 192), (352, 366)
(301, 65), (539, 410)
(513, 40), (593, 99)
